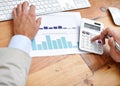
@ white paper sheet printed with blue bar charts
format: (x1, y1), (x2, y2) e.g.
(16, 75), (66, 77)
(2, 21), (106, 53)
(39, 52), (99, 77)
(30, 12), (84, 57)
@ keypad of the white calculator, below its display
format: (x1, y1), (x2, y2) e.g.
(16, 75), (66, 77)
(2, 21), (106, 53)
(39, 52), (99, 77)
(81, 31), (103, 54)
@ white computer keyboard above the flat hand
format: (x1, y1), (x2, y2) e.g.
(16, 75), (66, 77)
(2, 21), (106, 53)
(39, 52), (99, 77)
(0, 0), (91, 21)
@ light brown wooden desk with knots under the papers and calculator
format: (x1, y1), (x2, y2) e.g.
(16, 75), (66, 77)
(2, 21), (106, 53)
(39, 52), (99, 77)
(0, 0), (120, 86)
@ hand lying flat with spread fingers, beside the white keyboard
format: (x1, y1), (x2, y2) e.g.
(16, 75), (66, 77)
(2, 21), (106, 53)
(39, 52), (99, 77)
(13, 2), (41, 39)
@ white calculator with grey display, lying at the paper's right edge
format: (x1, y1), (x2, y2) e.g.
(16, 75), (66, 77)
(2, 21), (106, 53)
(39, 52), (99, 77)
(79, 18), (103, 55)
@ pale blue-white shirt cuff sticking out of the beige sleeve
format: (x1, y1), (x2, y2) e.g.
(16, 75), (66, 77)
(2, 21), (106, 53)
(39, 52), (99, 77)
(8, 35), (32, 53)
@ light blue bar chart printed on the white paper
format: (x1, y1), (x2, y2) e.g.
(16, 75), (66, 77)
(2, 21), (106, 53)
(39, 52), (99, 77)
(32, 35), (79, 50)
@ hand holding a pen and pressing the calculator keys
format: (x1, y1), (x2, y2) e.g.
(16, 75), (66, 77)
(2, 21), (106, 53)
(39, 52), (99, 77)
(91, 28), (120, 62)
